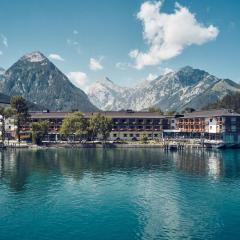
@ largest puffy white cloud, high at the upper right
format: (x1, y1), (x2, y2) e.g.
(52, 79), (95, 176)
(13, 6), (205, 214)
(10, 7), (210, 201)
(129, 1), (219, 69)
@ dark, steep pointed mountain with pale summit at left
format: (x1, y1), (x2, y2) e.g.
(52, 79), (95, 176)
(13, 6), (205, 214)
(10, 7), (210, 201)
(0, 52), (97, 112)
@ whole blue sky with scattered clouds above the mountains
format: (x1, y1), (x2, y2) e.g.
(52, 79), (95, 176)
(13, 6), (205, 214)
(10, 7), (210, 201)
(0, 0), (240, 88)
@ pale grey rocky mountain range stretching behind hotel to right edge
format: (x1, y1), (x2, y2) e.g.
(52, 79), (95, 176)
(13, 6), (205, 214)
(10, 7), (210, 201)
(87, 66), (240, 111)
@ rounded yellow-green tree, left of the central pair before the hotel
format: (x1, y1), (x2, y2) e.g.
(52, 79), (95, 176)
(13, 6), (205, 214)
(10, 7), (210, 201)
(60, 112), (88, 141)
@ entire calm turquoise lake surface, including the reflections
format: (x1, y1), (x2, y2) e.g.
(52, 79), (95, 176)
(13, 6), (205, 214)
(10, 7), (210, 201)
(0, 149), (240, 240)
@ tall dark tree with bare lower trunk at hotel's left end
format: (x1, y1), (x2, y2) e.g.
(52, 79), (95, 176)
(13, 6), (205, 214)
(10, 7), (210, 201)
(10, 96), (29, 143)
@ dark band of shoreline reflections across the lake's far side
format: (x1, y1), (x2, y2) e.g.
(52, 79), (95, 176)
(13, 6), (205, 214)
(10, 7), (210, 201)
(0, 149), (240, 191)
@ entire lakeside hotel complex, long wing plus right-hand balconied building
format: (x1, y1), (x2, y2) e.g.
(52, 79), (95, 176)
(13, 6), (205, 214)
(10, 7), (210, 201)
(5, 109), (240, 144)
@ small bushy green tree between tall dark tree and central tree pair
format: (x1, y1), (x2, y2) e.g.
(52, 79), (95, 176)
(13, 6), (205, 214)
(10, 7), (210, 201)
(32, 121), (48, 145)
